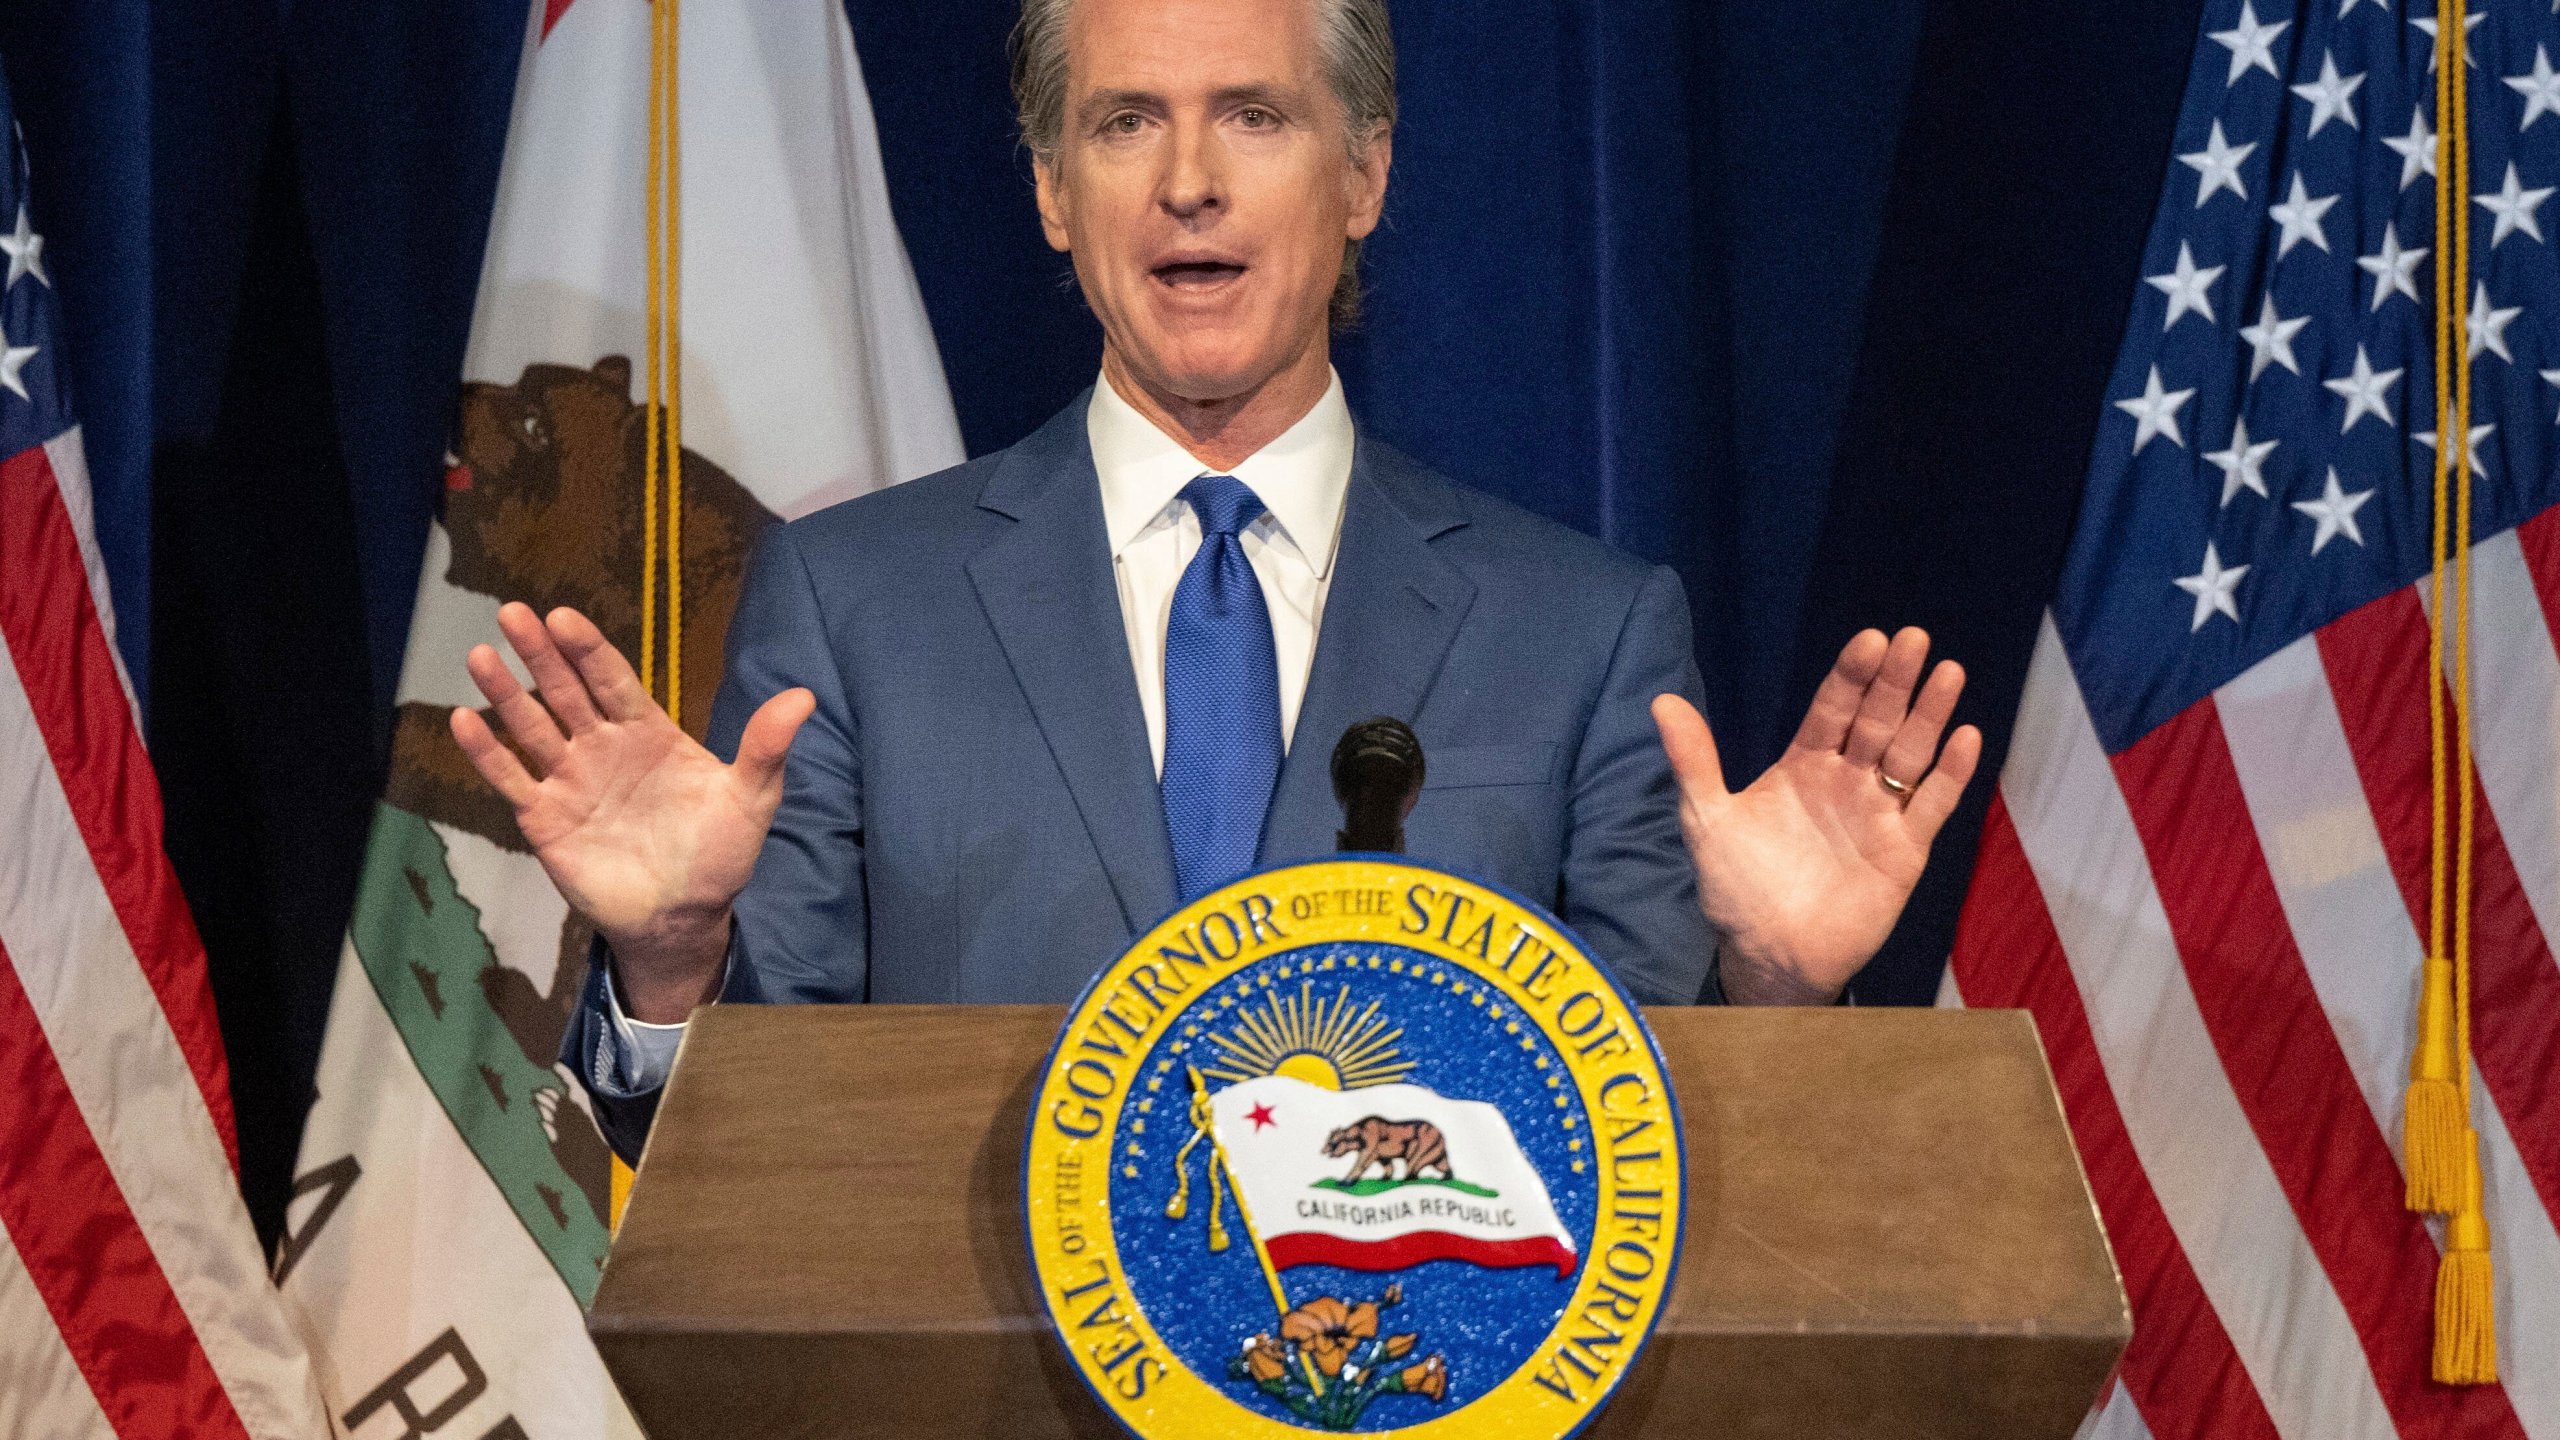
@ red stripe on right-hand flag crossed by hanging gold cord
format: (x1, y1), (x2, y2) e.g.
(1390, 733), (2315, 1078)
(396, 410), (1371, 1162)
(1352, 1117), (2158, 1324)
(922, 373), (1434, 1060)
(2319, 584), (2560, 1217)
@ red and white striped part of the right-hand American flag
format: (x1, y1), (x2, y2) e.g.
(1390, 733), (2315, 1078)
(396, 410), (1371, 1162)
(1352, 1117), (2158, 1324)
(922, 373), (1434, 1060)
(1948, 510), (2560, 1440)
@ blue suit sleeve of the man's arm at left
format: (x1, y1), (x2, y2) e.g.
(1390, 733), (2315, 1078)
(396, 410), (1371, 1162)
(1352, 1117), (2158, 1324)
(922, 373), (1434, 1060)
(561, 525), (870, 1158)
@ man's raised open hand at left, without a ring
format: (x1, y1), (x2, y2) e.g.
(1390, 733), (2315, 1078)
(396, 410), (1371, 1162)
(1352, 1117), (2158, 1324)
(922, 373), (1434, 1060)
(453, 602), (817, 1022)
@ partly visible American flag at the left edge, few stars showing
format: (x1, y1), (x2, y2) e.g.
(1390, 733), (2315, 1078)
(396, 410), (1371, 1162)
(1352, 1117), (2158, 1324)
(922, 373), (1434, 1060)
(0, 64), (328, 1440)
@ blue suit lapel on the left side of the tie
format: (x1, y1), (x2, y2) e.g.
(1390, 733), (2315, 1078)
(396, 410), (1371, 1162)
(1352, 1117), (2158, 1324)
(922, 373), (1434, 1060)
(968, 400), (1175, 930)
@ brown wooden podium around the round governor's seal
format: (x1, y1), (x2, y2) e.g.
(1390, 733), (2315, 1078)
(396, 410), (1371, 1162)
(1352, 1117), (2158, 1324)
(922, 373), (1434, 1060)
(589, 1004), (2130, 1440)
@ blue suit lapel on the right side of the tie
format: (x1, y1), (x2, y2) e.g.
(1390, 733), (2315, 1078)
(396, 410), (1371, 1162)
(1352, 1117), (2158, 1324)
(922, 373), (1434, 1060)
(1262, 436), (1475, 863)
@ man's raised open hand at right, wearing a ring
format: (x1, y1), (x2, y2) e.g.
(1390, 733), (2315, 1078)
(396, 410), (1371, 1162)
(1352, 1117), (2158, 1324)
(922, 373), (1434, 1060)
(1654, 630), (1981, 1002)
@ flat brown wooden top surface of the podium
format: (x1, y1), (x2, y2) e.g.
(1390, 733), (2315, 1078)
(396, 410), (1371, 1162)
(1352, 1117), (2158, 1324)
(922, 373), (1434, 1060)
(589, 1007), (2130, 1343)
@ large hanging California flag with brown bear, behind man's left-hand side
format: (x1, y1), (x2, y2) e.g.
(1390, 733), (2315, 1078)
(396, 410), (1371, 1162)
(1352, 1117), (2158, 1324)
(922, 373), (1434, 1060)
(276, 0), (963, 1440)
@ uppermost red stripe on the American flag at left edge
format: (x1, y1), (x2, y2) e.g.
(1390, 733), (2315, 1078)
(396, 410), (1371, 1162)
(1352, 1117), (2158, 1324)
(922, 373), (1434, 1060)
(0, 446), (241, 1171)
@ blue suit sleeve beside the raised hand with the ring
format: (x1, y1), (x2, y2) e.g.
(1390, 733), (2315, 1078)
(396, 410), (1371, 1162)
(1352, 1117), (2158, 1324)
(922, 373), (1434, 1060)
(1559, 556), (1723, 1004)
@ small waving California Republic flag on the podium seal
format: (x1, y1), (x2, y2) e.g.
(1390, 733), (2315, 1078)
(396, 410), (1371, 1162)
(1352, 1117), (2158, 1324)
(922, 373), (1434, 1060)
(1208, 1076), (1577, 1276)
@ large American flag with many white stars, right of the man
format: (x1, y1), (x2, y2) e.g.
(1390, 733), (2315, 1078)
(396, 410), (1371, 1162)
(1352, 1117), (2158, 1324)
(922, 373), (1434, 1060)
(1948, 0), (2560, 1440)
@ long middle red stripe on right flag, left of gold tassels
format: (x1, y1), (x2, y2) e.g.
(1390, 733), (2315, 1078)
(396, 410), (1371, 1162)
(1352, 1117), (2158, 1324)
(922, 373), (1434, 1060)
(2115, 696), (2524, 1437)
